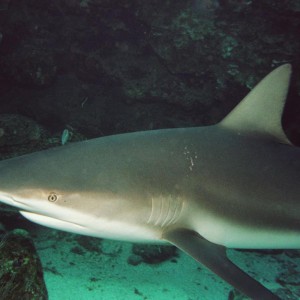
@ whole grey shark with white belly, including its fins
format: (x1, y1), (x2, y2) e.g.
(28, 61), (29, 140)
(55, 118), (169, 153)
(0, 64), (300, 300)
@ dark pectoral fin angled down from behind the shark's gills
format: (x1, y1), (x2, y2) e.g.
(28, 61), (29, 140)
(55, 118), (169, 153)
(163, 228), (280, 300)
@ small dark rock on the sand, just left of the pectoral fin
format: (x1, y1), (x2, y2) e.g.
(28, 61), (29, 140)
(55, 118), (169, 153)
(127, 244), (177, 265)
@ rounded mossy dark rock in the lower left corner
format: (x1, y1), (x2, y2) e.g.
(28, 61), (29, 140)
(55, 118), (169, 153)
(0, 229), (48, 300)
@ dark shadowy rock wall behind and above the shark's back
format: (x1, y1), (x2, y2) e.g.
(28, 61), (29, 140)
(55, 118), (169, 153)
(0, 0), (299, 140)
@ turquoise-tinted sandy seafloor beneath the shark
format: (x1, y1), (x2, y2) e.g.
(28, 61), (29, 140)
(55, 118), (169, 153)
(34, 227), (300, 300)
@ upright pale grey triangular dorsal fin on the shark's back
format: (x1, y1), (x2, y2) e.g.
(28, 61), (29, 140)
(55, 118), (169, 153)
(219, 64), (292, 144)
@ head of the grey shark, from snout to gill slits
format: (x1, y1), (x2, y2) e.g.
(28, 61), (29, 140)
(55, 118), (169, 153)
(0, 146), (162, 242)
